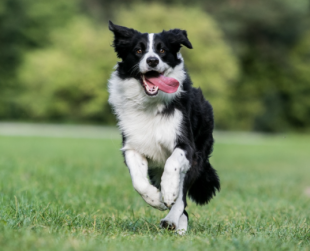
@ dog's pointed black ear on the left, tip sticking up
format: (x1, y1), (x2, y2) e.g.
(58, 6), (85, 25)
(109, 21), (139, 58)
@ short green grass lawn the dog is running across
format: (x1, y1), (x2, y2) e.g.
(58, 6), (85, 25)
(0, 134), (310, 251)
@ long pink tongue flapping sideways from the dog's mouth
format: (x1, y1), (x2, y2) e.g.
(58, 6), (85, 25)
(145, 75), (180, 93)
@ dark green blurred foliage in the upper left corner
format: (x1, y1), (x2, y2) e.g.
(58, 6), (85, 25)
(0, 0), (77, 118)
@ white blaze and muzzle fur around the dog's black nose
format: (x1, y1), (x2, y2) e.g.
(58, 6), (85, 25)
(139, 33), (168, 73)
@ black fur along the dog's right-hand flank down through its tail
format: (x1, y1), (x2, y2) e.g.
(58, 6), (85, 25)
(164, 77), (220, 205)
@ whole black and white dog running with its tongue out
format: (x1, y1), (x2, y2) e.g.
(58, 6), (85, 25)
(109, 21), (220, 234)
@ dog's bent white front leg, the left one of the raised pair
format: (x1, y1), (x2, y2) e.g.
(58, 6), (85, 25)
(125, 150), (167, 211)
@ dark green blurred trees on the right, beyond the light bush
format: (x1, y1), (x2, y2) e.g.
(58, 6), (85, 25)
(205, 0), (310, 132)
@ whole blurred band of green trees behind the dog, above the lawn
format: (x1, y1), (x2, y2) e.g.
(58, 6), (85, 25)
(0, 0), (310, 132)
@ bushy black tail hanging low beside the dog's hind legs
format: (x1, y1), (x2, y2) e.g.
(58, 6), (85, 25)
(188, 162), (221, 205)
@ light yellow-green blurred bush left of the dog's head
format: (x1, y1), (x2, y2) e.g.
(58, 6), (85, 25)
(18, 17), (115, 123)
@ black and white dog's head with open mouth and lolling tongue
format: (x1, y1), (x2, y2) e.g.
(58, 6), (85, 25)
(109, 21), (193, 96)
